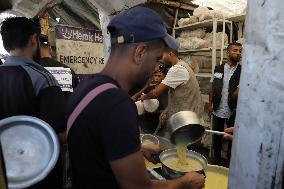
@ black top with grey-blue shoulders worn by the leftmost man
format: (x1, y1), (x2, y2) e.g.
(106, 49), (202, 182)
(0, 56), (66, 133)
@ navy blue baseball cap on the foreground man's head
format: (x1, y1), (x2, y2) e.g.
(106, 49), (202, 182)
(107, 7), (180, 50)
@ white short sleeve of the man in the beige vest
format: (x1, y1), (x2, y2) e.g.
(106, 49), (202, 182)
(162, 60), (189, 89)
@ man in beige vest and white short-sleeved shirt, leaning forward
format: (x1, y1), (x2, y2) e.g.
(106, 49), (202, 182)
(141, 51), (203, 123)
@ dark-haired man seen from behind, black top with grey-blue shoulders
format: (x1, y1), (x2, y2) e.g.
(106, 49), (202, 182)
(0, 17), (66, 189)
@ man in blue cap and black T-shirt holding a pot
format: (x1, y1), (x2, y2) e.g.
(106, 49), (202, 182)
(67, 7), (204, 189)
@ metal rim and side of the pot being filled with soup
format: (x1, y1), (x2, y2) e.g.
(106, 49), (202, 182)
(159, 149), (207, 179)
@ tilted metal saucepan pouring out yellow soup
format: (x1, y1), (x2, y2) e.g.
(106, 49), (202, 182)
(168, 111), (205, 145)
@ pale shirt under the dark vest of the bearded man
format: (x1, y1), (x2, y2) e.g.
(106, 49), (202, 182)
(213, 64), (237, 119)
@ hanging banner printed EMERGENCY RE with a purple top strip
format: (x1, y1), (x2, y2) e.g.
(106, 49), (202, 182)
(55, 25), (104, 74)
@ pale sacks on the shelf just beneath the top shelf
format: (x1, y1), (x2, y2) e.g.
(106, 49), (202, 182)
(177, 28), (228, 50)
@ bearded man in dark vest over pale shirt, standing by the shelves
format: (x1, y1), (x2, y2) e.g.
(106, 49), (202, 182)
(208, 43), (242, 163)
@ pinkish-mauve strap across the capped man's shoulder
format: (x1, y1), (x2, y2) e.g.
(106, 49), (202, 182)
(67, 83), (117, 134)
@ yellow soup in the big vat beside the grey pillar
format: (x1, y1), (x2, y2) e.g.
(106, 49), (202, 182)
(205, 172), (228, 189)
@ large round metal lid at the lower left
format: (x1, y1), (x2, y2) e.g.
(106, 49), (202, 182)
(0, 116), (59, 189)
